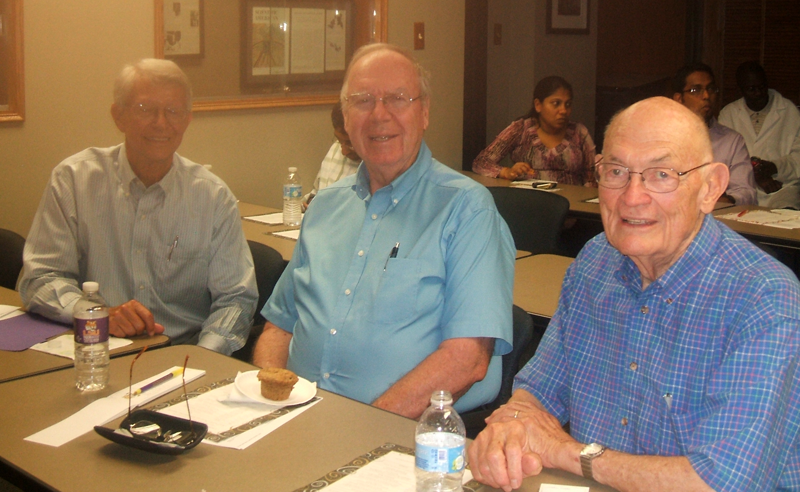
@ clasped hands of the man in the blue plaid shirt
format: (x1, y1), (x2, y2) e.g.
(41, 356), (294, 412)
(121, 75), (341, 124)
(468, 400), (583, 492)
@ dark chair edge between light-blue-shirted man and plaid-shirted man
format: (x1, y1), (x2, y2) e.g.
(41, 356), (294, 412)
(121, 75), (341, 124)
(461, 304), (533, 439)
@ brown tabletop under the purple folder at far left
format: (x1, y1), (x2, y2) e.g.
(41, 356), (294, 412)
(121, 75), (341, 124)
(0, 287), (169, 383)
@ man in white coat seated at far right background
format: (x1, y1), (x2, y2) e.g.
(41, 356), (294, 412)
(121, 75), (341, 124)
(719, 62), (800, 209)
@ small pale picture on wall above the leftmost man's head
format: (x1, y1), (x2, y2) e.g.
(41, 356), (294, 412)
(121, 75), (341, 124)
(163, 0), (205, 59)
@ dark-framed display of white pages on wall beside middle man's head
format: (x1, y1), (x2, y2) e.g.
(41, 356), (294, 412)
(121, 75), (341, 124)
(241, 0), (356, 93)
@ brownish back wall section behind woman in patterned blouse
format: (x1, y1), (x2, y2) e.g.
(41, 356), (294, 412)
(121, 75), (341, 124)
(486, 0), (599, 146)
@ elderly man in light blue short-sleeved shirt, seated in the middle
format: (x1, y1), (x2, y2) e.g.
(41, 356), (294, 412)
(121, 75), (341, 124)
(254, 45), (514, 418)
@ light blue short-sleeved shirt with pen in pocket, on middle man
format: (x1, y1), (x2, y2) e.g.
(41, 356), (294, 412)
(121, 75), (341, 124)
(262, 142), (515, 410)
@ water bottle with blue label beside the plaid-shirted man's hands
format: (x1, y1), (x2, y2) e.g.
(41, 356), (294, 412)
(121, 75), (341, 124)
(414, 391), (467, 492)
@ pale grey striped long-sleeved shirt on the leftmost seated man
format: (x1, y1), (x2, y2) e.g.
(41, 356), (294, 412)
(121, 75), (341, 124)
(20, 145), (258, 354)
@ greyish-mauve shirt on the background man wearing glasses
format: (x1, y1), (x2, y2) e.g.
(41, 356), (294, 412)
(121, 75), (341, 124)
(708, 118), (758, 205)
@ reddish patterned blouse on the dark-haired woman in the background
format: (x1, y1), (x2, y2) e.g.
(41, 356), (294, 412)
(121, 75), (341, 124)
(472, 118), (595, 185)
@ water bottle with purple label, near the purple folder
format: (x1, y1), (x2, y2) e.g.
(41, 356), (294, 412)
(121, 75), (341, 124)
(72, 282), (108, 391)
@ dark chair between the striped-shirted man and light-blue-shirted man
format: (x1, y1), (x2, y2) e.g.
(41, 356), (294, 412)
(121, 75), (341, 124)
(232, 240), (286, 362)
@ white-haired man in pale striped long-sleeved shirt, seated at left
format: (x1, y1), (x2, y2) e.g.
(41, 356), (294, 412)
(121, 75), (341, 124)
(20, 59), (258, 355)
